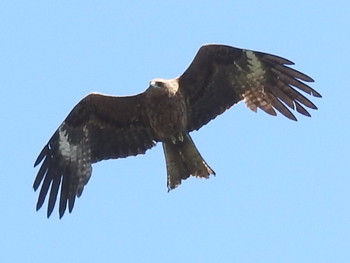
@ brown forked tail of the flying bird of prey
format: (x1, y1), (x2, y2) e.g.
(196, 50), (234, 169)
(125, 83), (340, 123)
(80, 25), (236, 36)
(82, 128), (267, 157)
(163, 133), (215, 191)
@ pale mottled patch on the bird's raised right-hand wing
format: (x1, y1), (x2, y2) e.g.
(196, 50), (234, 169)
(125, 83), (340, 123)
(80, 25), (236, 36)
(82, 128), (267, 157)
(242, 50), (276, 115)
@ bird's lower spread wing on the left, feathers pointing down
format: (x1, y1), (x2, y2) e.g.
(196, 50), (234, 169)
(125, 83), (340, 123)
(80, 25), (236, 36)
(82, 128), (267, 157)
(33, 93), (155, 218)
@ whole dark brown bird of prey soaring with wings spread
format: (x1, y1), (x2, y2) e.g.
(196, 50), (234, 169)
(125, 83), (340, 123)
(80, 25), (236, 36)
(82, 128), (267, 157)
(33, 45), (321, 218)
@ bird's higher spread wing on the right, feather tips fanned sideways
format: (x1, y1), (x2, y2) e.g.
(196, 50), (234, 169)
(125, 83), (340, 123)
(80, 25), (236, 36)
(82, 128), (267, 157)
(179, 45), (321, 131)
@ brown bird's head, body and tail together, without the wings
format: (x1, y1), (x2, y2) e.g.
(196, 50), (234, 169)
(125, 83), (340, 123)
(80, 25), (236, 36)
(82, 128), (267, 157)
(146, 79), (215, 190)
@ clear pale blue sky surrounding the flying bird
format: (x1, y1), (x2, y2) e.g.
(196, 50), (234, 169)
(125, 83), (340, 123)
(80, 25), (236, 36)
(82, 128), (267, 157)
(0, 0), (350, 263)
